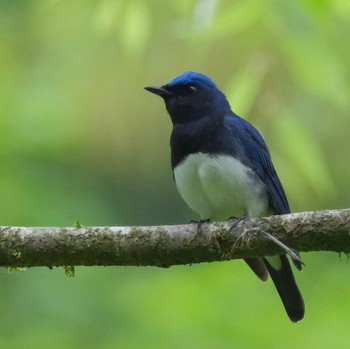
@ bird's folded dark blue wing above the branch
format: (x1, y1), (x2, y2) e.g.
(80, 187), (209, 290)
(224, 115), (290, 214)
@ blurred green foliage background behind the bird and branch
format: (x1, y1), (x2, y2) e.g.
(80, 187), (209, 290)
(0, 0), (350, 349)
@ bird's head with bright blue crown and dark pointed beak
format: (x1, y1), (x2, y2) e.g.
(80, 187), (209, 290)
(145, 71), (230, 124)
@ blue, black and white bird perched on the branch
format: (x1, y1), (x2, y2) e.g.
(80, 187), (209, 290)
(144, 71), (305, 322)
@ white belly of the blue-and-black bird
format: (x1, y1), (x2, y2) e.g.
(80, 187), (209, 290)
(174, 153), (268, 220)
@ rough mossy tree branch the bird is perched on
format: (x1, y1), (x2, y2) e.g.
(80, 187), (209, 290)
(0, 209), (350, 267)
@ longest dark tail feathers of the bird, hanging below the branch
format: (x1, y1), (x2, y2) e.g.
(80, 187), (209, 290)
(263, 255), (305, 322)
